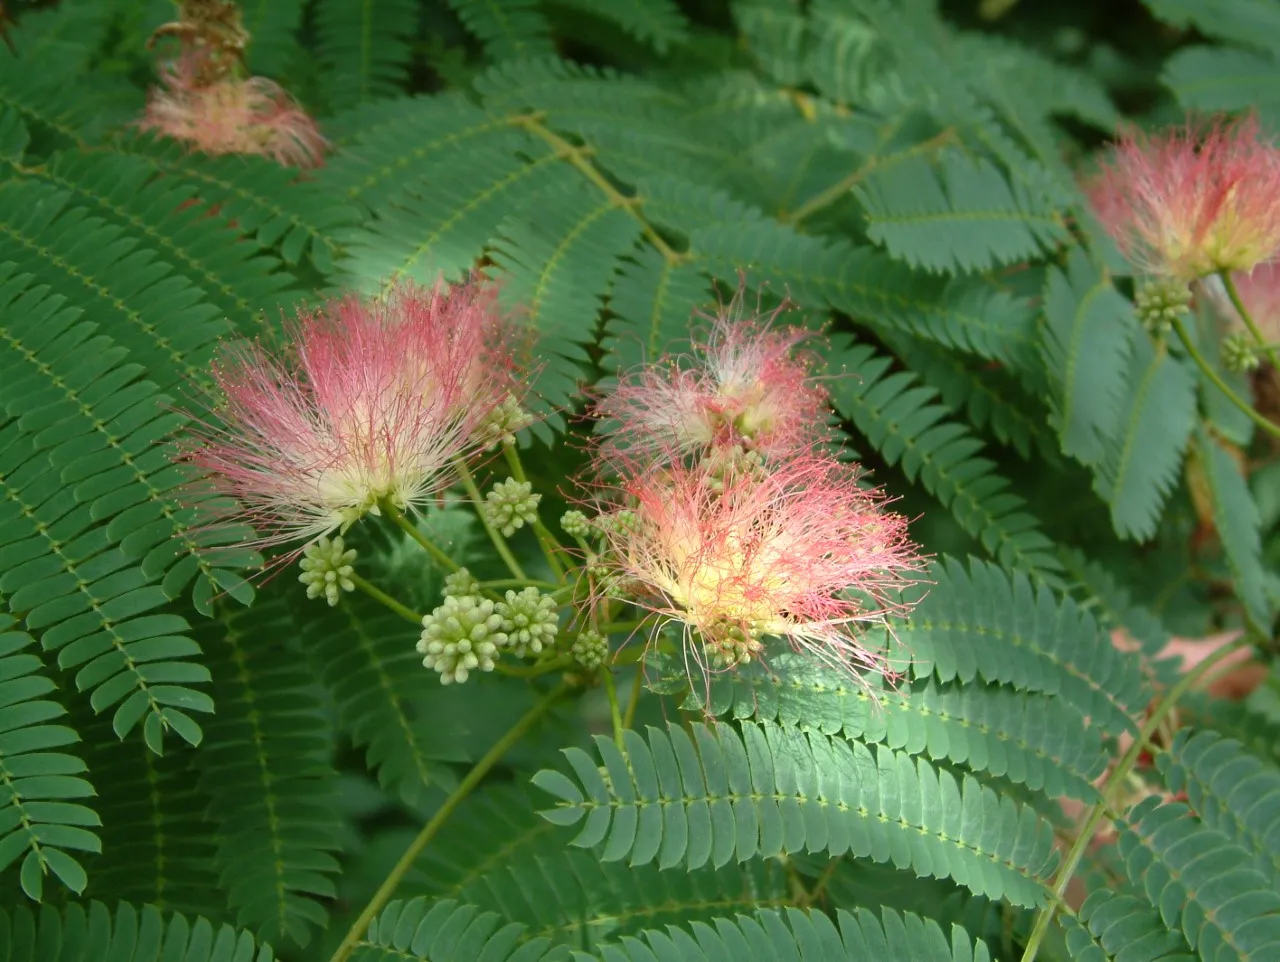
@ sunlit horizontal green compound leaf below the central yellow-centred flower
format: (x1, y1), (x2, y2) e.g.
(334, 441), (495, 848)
(534, 723), (1053, 906)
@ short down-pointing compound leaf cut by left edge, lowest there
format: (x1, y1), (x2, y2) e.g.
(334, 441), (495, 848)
(0, 611), (102, 902)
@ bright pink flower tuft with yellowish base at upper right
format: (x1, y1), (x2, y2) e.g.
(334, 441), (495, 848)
(1091, 118), (1280, 281)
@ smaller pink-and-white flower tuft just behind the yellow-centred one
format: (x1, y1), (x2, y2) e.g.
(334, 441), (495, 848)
(596, 290), (827, 473)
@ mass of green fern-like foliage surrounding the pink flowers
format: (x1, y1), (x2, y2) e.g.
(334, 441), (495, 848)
(0, 0), (1280, 962)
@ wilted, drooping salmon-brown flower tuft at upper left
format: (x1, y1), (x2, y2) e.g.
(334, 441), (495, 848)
(138, 54), (328, 168)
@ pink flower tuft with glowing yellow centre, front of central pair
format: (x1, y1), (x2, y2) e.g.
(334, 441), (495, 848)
(593, 455), (920, 670)
